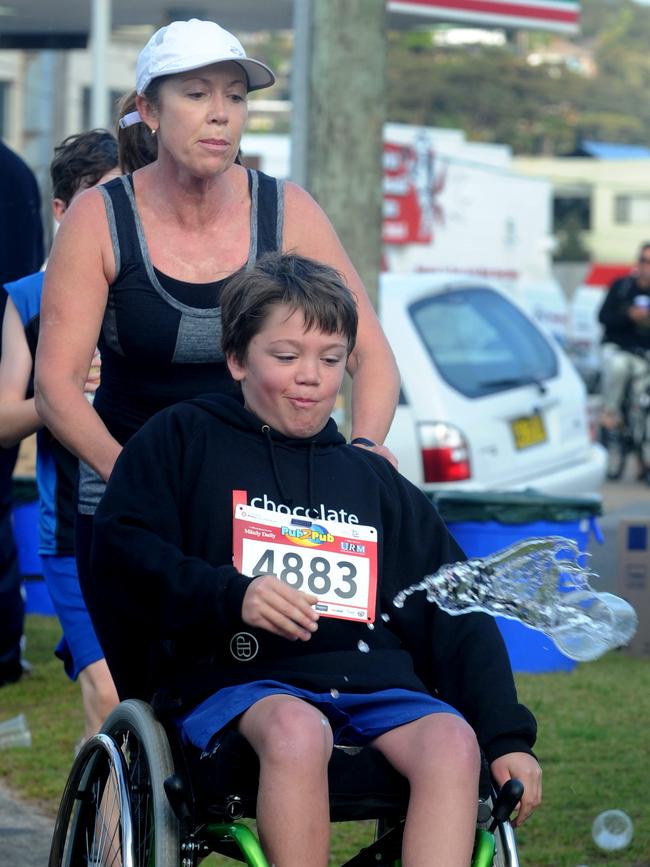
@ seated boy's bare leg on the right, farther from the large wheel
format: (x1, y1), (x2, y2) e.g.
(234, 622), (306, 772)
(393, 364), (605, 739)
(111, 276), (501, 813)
(372, 713), (480, 867)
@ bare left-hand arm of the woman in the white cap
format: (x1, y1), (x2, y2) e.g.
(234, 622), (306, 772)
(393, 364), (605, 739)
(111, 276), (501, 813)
(35, 190), (121, 479)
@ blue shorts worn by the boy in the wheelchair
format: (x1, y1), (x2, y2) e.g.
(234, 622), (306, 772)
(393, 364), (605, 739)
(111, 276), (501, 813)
(177, 680), (462, 751)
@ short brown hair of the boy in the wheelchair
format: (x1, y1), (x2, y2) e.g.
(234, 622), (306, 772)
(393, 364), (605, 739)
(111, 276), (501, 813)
(220, 253), (358, 364)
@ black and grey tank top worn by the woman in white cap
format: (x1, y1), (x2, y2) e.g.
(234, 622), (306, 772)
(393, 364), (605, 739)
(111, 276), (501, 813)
(78, 169), (284, 514)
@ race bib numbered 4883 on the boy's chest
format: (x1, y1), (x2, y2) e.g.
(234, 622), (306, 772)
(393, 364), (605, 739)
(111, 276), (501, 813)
(233, 504), (377, 623)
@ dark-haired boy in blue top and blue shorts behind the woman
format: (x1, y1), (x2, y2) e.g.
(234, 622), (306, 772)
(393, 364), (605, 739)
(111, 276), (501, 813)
(0, 130), (119, 736)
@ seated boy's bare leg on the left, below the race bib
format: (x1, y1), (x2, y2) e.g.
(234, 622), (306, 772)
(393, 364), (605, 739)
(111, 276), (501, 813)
(239, 695), (332, 867)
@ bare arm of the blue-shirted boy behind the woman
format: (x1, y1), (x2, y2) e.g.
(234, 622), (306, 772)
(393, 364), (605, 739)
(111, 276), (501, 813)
(0, 297), (42, 448)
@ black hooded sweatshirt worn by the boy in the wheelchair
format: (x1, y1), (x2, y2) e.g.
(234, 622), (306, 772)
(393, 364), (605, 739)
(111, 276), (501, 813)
(91, 395), (536, 761)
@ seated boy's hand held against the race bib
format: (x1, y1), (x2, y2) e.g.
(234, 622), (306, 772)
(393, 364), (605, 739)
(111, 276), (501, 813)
(242, 575), (318, 641)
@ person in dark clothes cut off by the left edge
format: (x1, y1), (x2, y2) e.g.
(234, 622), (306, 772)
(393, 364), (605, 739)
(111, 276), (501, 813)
(0, 141), (44, 686)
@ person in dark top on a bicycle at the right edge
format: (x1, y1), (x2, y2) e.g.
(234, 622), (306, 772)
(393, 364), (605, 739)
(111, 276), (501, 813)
(598, 242), (650, 430)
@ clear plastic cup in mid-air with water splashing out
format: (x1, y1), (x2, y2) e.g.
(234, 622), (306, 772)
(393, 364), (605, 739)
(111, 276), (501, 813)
(393, 536), (638, 662)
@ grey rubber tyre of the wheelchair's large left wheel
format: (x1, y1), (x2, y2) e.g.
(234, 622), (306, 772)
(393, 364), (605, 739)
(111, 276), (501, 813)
(102, 699), (180, 867)
